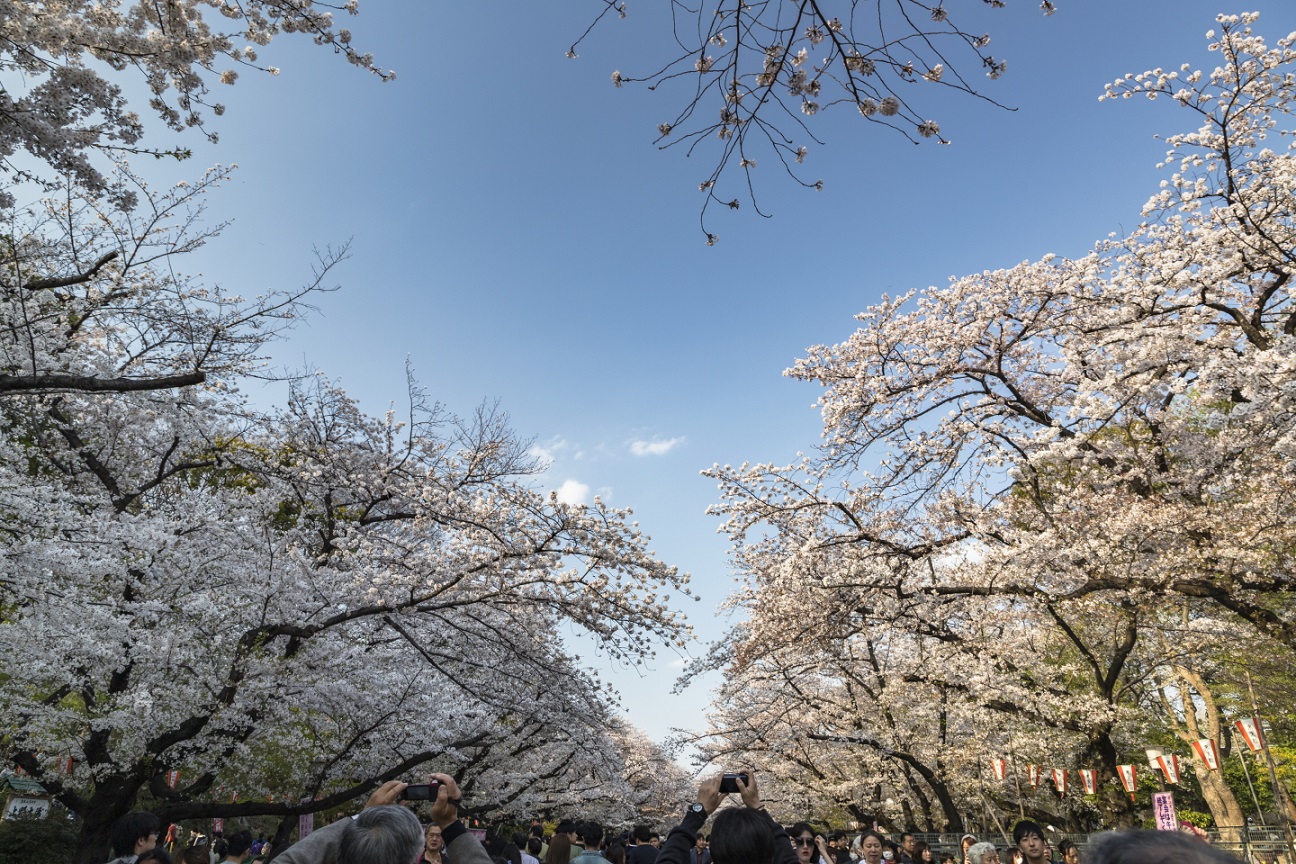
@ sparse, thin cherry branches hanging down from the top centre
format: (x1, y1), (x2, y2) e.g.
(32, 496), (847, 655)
(578, 0), (1056, 244)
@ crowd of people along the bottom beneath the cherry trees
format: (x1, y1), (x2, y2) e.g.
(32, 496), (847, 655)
(109, 773), (1254, 864)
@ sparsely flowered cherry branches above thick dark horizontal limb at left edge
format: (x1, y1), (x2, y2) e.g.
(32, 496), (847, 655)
(0, 166), (346, 398)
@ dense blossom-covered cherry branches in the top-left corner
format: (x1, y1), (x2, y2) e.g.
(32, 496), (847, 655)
(0, 0), (394, 206)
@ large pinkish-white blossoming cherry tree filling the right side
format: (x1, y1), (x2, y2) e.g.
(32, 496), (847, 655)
(706, 16), (1296, 829)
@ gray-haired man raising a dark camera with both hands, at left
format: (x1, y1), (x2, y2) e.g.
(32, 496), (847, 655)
(275, 775), (491, 864)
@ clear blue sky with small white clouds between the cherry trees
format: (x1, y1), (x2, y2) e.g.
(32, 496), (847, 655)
(134, 0), (1296, 751)
